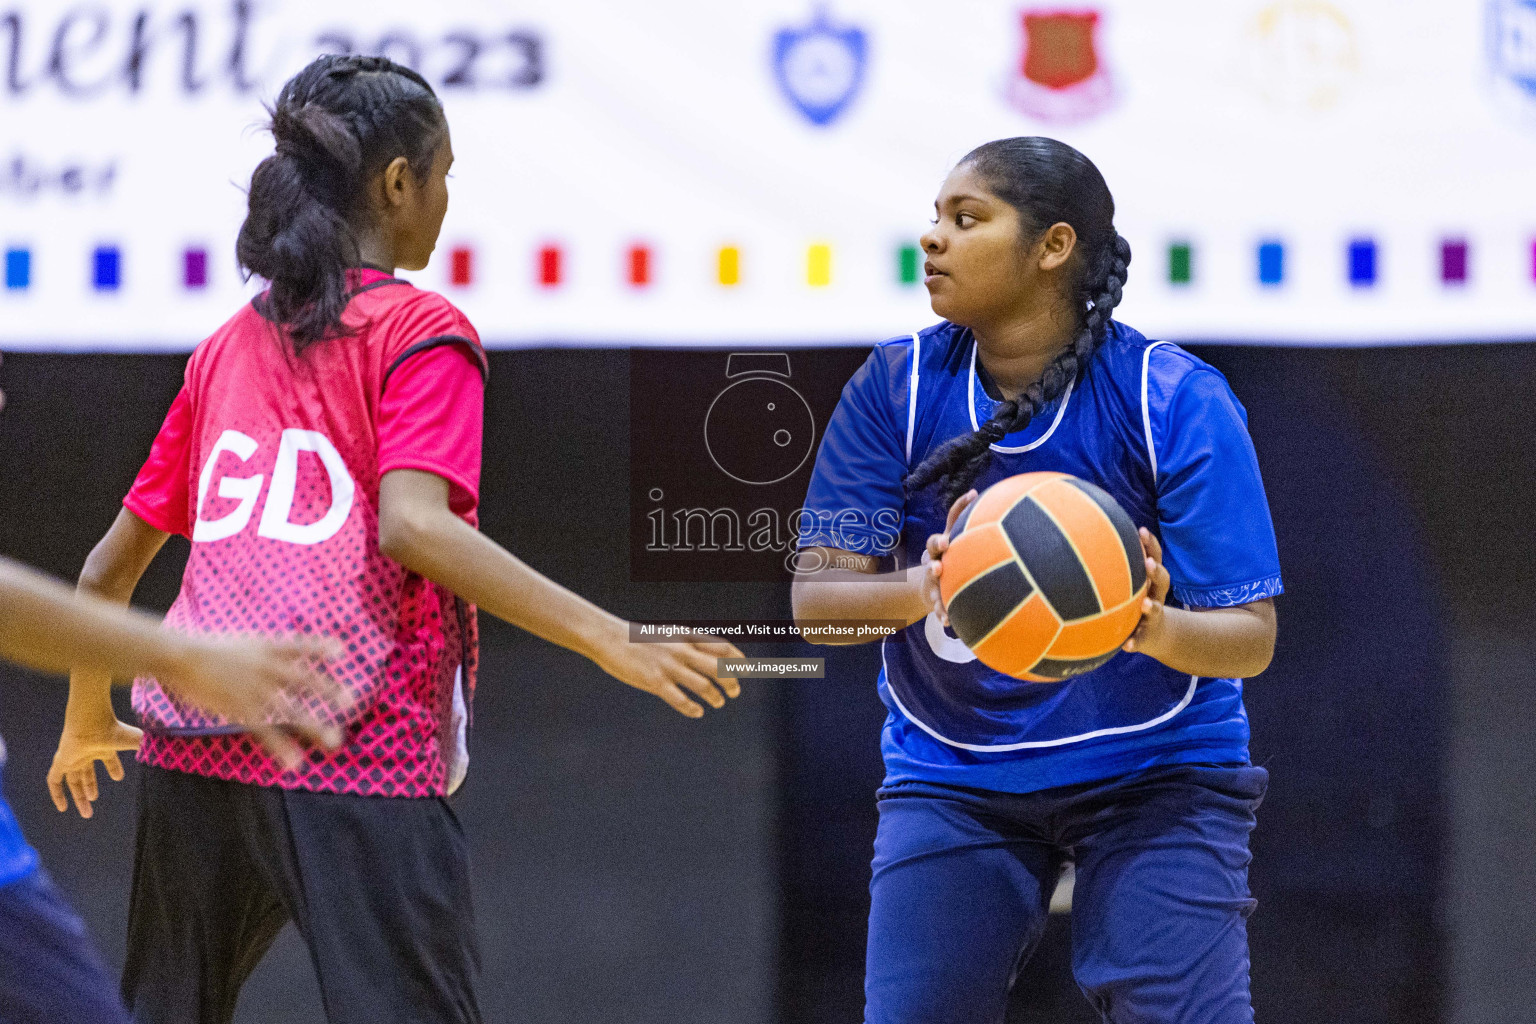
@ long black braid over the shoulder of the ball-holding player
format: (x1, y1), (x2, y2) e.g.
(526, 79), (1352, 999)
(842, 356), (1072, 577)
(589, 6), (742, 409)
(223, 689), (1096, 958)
(906, 233), (1130, 508)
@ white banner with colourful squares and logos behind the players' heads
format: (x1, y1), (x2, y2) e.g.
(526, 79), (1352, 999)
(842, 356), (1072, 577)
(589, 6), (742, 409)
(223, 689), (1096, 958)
(0, 0), (1536, 350)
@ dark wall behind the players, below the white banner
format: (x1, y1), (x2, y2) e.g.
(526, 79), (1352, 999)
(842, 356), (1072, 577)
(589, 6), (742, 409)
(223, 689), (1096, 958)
(0, 345), (1536, 1024)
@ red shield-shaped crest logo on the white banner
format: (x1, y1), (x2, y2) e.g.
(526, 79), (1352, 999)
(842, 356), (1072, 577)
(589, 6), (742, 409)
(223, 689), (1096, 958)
(1008, 8), (1115, 124)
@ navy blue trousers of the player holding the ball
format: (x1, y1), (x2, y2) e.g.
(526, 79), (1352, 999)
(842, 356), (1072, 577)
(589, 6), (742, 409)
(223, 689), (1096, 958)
(865, 765), (1269, 1024)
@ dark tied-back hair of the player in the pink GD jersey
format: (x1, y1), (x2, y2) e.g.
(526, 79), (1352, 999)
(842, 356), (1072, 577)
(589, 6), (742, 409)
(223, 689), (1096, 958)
(235, 55), (447, 352)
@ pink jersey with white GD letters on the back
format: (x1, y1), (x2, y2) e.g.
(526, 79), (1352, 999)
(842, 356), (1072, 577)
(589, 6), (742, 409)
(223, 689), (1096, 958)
(123, 270), (485, 797)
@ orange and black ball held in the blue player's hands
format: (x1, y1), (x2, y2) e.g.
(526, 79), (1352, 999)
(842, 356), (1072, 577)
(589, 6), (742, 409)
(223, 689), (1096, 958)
(938, 473), (1147, 683)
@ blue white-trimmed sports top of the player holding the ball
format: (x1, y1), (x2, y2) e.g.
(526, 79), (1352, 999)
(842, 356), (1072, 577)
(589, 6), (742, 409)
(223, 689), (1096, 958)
(800, 322), (1283, 792)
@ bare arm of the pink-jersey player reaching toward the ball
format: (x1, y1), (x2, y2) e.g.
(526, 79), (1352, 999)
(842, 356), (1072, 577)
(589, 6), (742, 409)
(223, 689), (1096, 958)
(379, 470), (742, 718)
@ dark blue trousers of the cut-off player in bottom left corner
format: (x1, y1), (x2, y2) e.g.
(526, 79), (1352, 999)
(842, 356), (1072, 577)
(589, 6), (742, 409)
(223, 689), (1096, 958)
(0, 869), (127, 1024)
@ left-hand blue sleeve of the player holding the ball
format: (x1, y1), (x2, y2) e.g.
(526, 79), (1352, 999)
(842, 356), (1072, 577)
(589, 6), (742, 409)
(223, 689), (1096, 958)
(799, 345), (906, 556)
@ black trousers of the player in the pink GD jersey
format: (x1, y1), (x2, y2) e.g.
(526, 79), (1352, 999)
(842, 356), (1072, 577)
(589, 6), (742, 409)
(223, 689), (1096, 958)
(123, 766), (481, 1024)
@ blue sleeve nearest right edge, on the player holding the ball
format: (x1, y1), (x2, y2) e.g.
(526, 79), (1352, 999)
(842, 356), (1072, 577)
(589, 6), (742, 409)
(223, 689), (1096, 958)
(1157, 368), (1284, 608)
